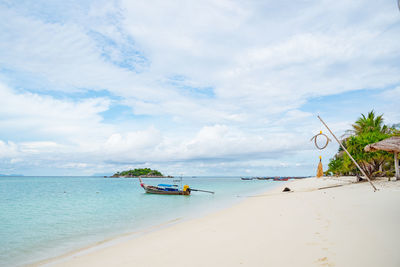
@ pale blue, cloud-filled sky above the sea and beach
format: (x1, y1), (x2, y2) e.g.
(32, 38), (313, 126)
(0, 0), (400, 176)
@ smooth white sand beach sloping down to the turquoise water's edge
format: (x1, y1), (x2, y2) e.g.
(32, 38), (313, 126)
(36, 178), (400, 267)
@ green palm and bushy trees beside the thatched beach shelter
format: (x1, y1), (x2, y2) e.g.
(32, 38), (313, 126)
(325, 111), (399, 177)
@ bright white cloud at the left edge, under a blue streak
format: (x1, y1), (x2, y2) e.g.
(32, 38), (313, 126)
(0, 84), (112, 147)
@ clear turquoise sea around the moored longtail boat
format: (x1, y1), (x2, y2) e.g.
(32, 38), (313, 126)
(0, 177), (279, 266)
